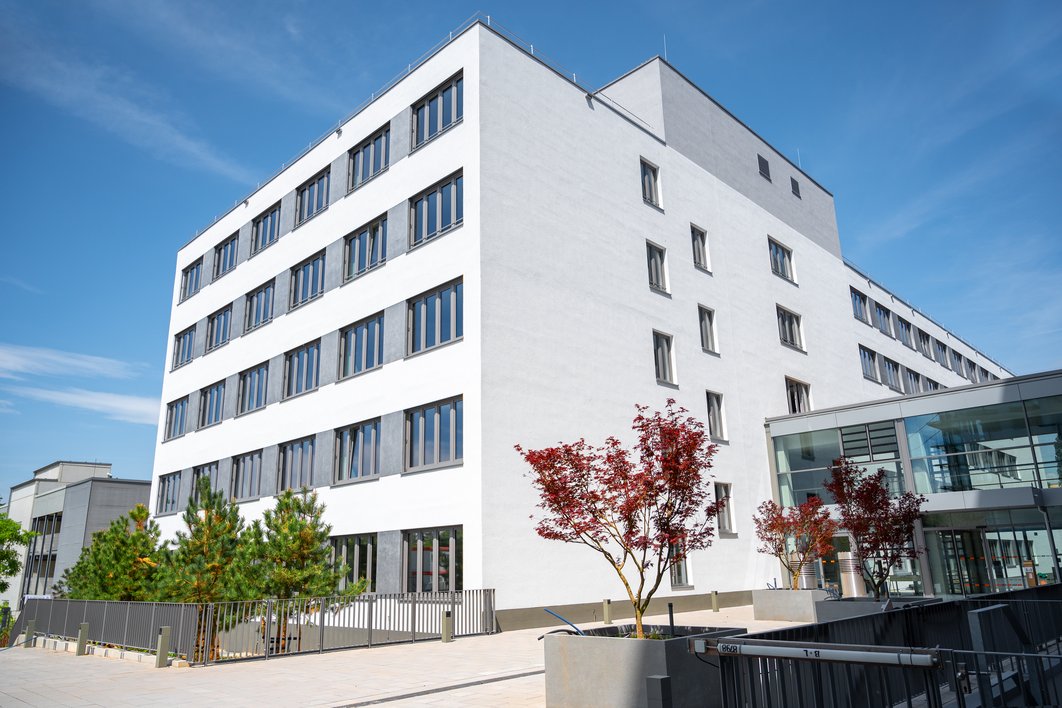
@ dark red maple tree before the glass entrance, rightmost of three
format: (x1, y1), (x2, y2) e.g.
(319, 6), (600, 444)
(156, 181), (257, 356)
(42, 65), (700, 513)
(823, 457), (928, 600)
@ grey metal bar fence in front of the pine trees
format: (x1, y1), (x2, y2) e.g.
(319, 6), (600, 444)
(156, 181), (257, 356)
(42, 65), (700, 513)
(11, 590), (495, 664)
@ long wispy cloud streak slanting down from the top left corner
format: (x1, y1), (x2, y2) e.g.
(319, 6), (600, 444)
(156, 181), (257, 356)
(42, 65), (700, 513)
(0, 7), (254, 184)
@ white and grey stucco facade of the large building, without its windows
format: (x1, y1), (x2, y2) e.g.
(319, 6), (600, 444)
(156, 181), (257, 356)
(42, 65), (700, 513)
(152, 23), (1009, 608)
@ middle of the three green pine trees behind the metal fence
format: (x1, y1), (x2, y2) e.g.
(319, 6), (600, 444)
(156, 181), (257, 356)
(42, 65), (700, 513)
(161, 477), (249, 603)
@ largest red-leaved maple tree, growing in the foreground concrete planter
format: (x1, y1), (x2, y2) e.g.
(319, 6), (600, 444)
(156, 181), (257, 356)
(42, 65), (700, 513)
(516, 399), (723, 639)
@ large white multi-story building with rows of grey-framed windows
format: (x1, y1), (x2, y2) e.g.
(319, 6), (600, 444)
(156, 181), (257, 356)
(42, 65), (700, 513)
(147, 22), (1009, 624)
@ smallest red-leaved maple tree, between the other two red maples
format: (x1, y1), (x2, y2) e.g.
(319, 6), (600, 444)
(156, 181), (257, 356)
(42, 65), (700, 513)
(752, 497), (839, 590)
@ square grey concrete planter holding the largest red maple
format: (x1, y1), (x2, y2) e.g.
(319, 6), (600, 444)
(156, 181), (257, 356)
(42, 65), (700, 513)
(545, 625), (746, 708)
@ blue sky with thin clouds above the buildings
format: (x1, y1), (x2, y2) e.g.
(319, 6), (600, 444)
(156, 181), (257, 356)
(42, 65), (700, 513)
(0, 0), (1062, 498)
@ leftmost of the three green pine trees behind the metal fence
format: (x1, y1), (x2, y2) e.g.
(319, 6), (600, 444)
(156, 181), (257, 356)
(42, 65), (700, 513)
(55, 504), (166, 602)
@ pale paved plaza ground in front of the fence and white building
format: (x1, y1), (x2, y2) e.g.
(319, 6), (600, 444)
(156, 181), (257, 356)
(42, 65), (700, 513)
(0, 606), (791, 708)
